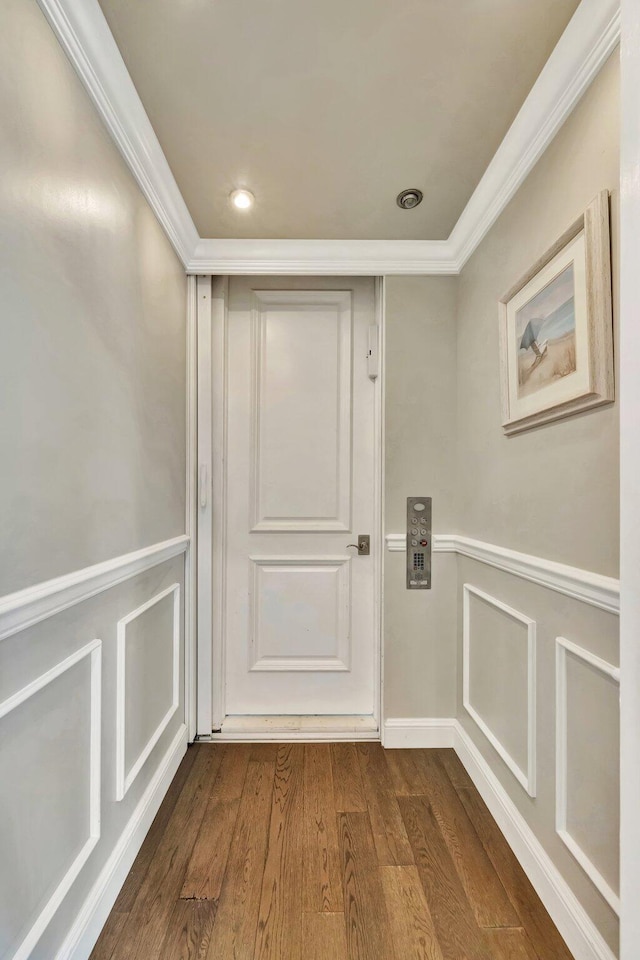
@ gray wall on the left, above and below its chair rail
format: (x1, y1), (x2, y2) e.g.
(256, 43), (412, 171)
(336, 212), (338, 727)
(0, 0), (186, 960)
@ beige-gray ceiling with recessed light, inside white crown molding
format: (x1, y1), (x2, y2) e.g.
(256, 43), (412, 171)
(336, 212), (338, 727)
(101, 0), (578, 240)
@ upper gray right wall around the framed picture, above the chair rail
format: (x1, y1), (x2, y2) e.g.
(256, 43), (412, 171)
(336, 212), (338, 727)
(457, 53), (619, 577)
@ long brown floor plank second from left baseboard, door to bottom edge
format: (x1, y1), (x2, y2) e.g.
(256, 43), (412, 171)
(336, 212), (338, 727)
(112, 745), (228, 960)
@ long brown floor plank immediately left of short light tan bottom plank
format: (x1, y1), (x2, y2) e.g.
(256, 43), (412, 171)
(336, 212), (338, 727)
(338, 813), (400, 960)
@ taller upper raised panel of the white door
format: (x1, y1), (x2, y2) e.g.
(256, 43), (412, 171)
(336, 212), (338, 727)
(250, 290), (353, 533)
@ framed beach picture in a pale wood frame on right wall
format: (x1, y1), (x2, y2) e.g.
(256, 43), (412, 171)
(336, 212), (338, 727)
(500, 190), (614, 435)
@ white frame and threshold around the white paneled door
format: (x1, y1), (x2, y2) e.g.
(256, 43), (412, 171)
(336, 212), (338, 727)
(196, 275), (385, 740)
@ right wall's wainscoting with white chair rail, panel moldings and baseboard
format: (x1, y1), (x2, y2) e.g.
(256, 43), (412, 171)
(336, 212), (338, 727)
(383, 534), (619, 960)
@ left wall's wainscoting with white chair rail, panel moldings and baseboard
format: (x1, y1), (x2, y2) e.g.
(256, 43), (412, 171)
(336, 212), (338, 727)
(0, 537), (189, 960)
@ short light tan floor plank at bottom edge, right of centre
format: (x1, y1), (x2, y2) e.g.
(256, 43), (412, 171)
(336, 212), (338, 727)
(380, 867), (443, 960)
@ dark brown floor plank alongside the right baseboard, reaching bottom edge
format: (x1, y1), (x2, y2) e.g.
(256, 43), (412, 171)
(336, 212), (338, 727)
(459, 787), (572, 960)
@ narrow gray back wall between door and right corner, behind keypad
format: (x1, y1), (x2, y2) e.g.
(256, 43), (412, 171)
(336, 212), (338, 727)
(384, 277), (457, 717)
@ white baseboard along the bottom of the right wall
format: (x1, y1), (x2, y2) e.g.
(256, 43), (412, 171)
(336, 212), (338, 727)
(455, 723), (616, 960)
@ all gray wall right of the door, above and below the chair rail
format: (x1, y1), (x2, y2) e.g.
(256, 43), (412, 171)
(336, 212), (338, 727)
(384, 53), (619, 952)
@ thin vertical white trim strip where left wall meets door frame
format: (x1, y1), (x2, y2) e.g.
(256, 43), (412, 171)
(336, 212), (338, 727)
(184, 277), (198, 742)
